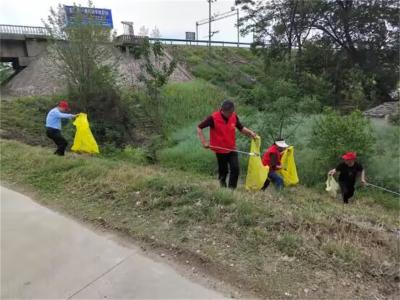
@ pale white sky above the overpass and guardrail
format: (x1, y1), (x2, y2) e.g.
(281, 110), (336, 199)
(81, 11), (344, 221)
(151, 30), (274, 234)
(0, 0), (252, 42)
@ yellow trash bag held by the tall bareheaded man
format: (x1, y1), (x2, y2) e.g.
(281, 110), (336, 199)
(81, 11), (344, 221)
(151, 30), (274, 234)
(245, 136), (269, 191)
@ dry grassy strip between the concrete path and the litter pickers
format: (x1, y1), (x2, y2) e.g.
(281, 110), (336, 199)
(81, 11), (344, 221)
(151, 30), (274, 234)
(1, 140), (399, 299)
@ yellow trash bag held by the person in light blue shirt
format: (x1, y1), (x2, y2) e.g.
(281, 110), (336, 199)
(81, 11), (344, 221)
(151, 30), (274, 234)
(71, 113), (99, 153)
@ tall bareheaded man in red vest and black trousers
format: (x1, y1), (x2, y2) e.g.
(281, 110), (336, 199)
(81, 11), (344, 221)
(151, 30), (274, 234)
(197, 100), (257, 189)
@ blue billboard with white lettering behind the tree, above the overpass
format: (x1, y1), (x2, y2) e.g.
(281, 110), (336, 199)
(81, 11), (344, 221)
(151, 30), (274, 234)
(64, 5), (113, 28)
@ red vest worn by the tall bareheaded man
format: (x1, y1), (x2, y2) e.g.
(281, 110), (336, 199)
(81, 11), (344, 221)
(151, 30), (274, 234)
(210, 111), (237, 153)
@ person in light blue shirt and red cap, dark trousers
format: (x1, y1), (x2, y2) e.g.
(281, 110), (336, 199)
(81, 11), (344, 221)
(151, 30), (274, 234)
(46, 101), (77, 156)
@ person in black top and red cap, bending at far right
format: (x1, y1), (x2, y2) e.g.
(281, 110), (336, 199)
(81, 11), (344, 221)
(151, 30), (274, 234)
(328, 152), (367, 203)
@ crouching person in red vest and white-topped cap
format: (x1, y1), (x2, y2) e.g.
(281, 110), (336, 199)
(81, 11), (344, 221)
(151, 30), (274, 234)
(262, 140), (289, 190)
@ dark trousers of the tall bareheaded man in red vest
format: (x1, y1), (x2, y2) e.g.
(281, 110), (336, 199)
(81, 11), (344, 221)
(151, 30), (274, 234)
(217, 152), (239, 189)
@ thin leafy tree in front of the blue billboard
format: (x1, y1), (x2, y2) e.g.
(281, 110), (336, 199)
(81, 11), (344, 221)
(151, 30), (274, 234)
(45, 2), (116, 111)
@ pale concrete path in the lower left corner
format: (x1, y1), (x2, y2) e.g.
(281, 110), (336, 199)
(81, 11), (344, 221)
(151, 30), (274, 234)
(0, 187), (227, 299)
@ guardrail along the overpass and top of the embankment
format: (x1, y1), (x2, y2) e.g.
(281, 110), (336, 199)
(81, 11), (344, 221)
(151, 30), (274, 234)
(0, 24), (251, 47)
